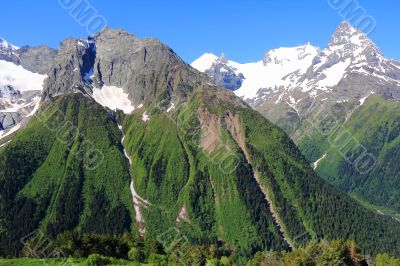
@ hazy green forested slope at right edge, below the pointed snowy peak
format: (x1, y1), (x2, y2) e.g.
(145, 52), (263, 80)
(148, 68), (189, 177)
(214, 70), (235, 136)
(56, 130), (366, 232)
(300, 95), (400, 212)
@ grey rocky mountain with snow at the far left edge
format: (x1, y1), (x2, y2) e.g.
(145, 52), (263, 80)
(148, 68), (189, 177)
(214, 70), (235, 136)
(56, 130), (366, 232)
(0, 39), (57, 139)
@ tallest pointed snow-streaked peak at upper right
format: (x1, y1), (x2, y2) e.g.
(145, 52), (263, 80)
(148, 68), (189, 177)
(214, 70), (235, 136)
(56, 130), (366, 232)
(300, 22), (400, 95)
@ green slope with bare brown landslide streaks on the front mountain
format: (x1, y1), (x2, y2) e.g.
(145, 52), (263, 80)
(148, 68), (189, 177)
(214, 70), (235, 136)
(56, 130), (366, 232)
(118, 86), (400, 252)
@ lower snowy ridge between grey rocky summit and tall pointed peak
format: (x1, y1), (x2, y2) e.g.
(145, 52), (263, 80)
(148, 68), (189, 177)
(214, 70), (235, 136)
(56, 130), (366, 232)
(192, 43), (319, 99)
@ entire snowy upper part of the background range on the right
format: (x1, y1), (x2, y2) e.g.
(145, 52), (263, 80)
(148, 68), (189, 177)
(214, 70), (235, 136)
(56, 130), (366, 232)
(192, 22), (400, 124)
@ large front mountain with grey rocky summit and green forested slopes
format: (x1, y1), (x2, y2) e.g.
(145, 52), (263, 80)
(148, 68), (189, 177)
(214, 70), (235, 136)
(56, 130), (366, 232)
(0, 29), (400, 256)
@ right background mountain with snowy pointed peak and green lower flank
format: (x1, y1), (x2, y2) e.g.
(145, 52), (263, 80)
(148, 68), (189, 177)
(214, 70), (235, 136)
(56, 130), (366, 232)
(193, 22), (400, 216)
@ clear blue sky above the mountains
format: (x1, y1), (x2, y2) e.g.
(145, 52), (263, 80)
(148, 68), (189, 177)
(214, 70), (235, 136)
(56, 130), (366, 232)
(0, 0), (400, 62)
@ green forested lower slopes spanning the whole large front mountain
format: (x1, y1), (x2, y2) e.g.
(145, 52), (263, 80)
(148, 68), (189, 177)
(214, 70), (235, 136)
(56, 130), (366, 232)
(0, 86), (400, 255)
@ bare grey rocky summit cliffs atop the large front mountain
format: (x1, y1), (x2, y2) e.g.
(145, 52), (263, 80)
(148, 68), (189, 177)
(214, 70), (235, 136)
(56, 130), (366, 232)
(42, 29), (210, 105)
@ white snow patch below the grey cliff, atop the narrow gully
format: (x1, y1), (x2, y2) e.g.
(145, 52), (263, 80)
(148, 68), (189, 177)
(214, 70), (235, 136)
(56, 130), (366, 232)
(93, 86), (135, 114)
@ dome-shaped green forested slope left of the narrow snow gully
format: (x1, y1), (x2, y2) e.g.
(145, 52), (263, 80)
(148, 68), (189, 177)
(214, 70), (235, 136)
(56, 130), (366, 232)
(0, 94), (132, 256)
